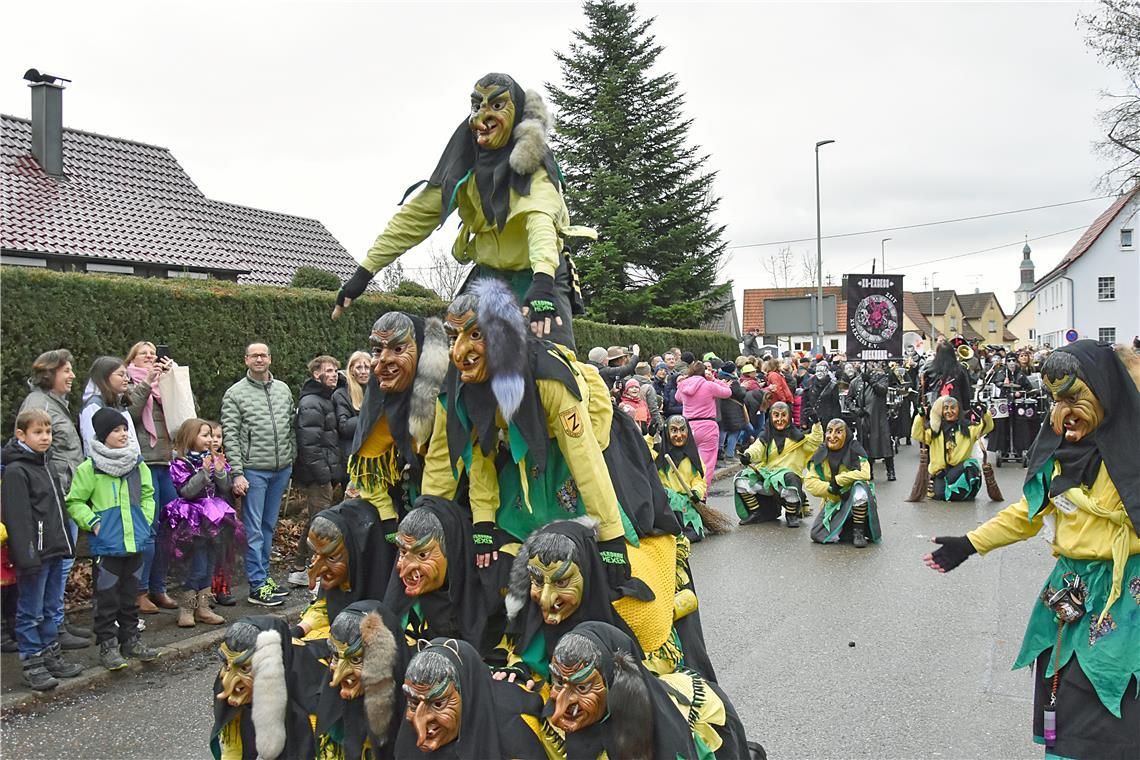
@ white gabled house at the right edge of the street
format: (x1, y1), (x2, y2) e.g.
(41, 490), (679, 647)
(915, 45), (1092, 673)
(1033, 185), (1140, 348)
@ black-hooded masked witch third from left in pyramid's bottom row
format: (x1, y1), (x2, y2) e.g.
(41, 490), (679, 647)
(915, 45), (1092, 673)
(396, 638), (557, 760)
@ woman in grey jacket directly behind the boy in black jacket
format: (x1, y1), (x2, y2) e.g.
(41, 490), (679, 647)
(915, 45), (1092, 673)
(17, 349), (93, 652)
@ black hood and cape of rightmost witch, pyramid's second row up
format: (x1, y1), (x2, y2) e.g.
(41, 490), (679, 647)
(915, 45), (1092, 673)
(507, 520), (640, 677)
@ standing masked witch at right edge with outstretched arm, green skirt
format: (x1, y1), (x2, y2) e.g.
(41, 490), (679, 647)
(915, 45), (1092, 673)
(925, 341), (1140, 760)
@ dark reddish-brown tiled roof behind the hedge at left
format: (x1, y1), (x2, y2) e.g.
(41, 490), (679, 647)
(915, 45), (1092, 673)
(0, 115), (357, 286)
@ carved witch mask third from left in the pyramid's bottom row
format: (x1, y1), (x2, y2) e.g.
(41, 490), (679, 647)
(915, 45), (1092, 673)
(404, 648), (463, 752)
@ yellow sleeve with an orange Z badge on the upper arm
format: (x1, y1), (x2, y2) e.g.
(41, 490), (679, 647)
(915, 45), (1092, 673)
(540, 379), (625, 541)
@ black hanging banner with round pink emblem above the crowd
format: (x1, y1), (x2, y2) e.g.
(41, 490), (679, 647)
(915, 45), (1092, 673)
(847, 275), (903, 361)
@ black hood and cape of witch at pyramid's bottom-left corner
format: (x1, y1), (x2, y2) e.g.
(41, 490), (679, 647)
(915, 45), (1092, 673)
(210, 615), (316, 760)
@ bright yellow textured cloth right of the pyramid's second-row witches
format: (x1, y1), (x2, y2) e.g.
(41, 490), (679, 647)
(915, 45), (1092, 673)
(613, 536), (677, 652)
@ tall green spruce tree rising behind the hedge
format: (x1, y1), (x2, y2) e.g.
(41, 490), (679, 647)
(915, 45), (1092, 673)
(546, 0), (732, 327)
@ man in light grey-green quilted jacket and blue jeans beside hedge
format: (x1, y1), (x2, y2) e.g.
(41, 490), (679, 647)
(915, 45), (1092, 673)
(221, 343), (296, 607)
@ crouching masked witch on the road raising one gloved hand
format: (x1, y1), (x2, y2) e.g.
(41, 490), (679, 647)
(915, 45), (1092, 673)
(733, 401), (823, 528)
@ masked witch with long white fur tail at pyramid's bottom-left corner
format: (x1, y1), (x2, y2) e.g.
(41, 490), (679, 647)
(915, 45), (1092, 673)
(210, 615), (315, 760)
